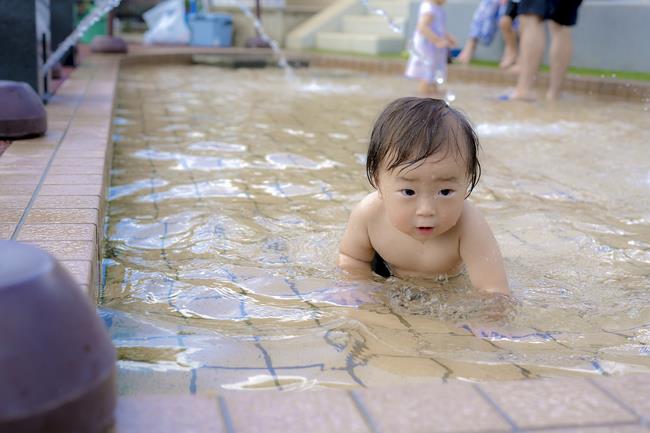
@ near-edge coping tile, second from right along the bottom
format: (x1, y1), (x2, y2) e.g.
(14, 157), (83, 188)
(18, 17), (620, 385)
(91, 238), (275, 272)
(480, 378), (636, 429)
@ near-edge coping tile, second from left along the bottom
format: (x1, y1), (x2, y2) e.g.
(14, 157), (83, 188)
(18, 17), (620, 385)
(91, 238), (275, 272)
(224, 391), (369, 433)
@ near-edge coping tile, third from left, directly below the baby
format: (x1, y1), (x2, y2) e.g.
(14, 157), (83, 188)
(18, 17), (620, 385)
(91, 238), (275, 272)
(358, 382), (511, 433)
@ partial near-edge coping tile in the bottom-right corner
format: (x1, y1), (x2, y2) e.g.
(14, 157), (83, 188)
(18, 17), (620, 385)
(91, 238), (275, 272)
(593, 374), (650, 420)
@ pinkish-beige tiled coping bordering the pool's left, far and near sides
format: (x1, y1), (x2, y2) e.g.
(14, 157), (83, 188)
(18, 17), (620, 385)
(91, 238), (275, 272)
(0, 46), (650, 433)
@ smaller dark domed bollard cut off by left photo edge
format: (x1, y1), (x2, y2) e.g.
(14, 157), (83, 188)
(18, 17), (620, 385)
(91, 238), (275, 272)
(0, 81), (47, 140)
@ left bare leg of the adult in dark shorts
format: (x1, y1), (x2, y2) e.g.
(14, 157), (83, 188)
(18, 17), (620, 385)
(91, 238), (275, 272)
(511, 14), (546, 99)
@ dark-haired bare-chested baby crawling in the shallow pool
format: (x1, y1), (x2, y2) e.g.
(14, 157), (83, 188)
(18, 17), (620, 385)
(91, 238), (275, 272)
(338, 97), (509, 294)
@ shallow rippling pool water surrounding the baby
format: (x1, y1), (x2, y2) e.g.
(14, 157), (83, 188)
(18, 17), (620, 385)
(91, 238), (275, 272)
(100, 66), (650, 394)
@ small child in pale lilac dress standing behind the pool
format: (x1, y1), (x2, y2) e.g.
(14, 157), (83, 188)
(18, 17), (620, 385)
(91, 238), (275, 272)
(405, 0), (456, 96)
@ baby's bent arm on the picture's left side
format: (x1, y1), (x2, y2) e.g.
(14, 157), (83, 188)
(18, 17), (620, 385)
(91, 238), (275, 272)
(338, 196), (375, 278)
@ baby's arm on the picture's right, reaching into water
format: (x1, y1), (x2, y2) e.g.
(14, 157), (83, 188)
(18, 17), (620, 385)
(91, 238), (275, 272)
(460, 201), (510, 294)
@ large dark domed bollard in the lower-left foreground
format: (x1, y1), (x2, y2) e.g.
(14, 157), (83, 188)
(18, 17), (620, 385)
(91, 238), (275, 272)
(0, 241), (116, 433)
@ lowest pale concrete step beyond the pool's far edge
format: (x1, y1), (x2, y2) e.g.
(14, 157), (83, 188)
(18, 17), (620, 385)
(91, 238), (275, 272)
(316, 32), (404, 54)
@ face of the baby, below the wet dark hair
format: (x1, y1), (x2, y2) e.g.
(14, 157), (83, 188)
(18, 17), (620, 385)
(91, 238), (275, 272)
(377, 152), (468, 242)
